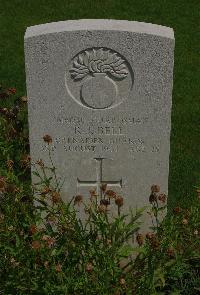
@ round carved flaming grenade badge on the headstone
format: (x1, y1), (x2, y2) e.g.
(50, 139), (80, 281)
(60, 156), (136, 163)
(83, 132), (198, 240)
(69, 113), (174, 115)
(66, 48), (133, 109)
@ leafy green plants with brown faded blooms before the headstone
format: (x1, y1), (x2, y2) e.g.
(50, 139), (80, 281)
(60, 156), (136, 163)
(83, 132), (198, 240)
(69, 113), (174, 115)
(0, 88), (200, 295)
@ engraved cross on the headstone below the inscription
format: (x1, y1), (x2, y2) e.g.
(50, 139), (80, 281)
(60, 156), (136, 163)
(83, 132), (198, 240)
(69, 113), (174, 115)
(77, 158), (122, 197)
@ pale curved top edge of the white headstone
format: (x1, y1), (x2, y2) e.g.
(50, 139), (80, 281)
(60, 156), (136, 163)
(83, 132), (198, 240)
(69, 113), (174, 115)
(25, 19), (174, 39)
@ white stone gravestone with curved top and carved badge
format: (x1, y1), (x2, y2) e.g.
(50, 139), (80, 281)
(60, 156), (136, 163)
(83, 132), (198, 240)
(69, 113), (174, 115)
(25, 20), (174, 228)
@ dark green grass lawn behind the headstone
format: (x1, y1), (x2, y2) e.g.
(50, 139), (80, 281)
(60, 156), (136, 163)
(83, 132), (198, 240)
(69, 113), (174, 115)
(0, 0), (200, 205)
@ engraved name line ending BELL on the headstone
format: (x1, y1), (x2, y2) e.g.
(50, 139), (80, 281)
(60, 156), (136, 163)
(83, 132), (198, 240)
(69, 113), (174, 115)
(74, 126), (124, 135)
